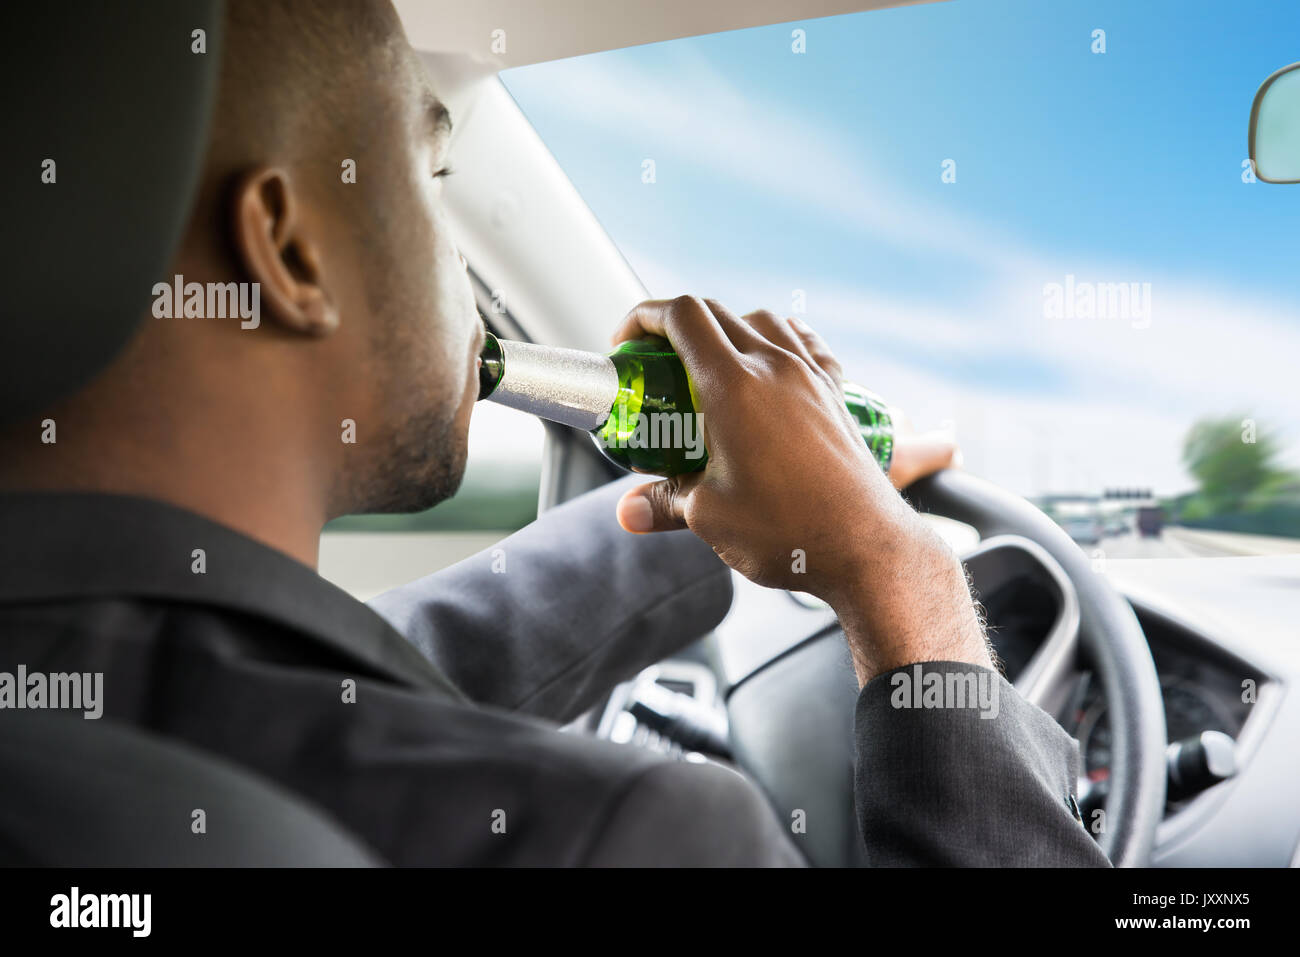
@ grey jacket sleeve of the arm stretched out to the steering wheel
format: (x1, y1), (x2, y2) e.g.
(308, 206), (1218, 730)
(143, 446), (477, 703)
(371, 476), (732, 723)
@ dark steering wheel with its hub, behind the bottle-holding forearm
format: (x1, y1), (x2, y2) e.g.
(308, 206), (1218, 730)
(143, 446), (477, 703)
(727, 471), (1166, 867)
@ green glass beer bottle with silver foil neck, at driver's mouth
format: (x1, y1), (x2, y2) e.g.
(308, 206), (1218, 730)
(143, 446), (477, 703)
(478, 333), (893, 475)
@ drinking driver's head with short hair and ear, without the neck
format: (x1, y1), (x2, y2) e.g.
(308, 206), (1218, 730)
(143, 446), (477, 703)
(200, 0), (480, 512)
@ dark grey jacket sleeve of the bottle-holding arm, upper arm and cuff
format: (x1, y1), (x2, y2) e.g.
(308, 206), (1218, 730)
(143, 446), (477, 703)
(559, 662), (1109, 867)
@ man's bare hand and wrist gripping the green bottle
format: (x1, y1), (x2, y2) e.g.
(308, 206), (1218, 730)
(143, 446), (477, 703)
(614, 296), (992, 684)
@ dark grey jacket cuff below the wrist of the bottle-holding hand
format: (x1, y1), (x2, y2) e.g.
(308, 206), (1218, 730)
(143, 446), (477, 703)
(854, 662), (1109, 867)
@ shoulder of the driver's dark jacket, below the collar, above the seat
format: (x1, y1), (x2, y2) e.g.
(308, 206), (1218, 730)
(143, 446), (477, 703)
(0, 590), (790, 865)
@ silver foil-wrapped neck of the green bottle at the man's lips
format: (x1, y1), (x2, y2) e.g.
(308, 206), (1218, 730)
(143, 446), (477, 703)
(478, 334), (619, 432)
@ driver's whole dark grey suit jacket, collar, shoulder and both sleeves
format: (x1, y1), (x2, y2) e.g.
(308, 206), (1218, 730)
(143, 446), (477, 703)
(0, 486), (1105, 865)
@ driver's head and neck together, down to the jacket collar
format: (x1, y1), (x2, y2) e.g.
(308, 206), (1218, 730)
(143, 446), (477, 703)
(0, 0), (481, 556)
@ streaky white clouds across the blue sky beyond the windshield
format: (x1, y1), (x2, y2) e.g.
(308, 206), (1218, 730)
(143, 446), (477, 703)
(514, 51), (1300, 494)
